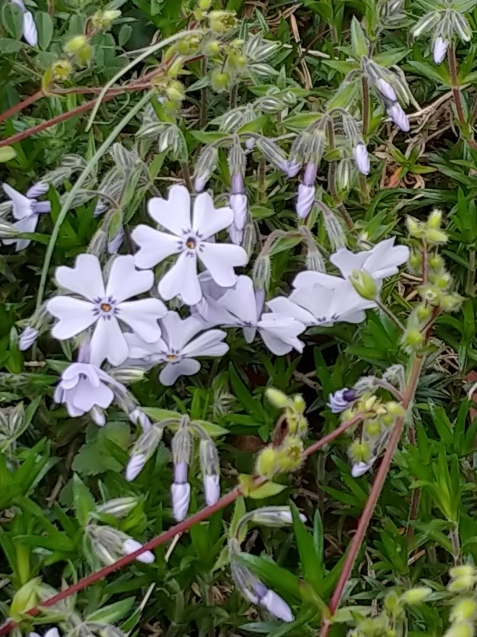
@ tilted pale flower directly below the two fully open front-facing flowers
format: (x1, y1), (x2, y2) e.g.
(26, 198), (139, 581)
(126, 312), (229, 386)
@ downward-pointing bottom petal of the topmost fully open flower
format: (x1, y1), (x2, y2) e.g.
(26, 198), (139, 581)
(157, 252), (202, 305)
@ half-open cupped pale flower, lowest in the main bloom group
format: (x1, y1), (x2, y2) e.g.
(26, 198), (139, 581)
(54, 363), (126, 424)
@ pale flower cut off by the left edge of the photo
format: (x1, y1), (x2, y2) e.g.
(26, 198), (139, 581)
(3, 183), (51, 252)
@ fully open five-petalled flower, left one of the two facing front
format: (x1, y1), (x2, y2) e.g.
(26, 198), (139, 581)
(47, 254), (167, 366)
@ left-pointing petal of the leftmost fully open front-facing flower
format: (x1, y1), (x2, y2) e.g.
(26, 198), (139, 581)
(46, 296), (97, 341)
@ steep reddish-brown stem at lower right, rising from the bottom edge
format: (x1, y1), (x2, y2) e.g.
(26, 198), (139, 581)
(320, 357), (422, 637)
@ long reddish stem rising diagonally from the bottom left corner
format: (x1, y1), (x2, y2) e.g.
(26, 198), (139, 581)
(0, 414), (362, 636)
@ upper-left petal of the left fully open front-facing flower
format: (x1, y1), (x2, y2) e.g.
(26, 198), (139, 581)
(55, 254), (105, 301)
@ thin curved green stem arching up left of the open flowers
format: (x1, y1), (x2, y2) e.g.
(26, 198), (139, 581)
(36, 91), (153, 309)
